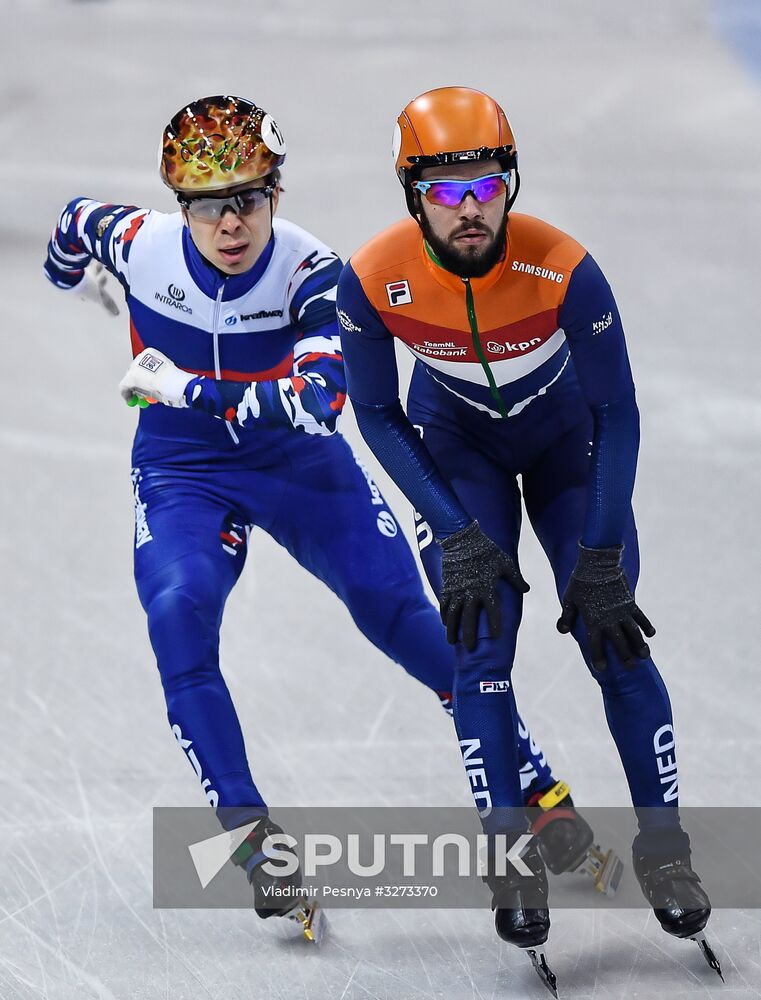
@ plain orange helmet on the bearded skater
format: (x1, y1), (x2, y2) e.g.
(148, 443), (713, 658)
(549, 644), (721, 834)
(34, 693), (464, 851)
(393, 87), (520, 216)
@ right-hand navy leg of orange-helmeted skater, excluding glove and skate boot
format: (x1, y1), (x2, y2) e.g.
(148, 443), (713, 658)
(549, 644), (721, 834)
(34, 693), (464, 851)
(523, 423), (679, 826)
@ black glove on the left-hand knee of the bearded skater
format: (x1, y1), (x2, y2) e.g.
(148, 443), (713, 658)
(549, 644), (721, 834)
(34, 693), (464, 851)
(441, 521), (529, 650)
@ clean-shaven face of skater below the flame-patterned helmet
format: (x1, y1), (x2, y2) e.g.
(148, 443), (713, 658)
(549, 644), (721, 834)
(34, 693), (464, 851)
(182, 178), (280, 274)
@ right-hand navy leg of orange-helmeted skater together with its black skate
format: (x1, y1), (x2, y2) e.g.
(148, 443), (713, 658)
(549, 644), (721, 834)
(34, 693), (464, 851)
(523, 424), (721, 975)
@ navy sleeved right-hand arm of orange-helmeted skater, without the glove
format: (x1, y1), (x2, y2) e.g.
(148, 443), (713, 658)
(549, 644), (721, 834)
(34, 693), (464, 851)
(559, 254), (639, 549)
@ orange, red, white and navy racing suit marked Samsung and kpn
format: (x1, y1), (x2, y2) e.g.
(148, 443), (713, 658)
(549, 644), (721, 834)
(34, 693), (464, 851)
(338, 213), (678, 830)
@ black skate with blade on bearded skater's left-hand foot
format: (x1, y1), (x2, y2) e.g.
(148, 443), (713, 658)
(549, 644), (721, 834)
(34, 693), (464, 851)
(486, 833), (558, 997)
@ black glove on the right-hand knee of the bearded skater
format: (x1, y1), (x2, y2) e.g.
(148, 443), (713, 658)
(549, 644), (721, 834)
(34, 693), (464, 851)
(558, 542), (655, 670)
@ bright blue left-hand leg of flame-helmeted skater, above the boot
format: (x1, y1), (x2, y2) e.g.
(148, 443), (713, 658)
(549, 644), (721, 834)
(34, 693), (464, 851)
(135, 473), (264, 829)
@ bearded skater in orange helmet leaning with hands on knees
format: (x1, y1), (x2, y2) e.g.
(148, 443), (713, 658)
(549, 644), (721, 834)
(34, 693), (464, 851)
(338, 87), (716, 985)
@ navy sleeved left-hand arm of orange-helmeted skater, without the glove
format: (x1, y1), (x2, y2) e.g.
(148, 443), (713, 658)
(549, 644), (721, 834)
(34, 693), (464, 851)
(338, 264), (473, 540)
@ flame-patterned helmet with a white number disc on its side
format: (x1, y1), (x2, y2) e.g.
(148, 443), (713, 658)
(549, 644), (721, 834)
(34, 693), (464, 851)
(159, 97), (285, 194)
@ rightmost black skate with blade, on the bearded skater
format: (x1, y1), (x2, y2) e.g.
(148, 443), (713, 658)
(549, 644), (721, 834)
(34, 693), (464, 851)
(632, 829), (724, 982)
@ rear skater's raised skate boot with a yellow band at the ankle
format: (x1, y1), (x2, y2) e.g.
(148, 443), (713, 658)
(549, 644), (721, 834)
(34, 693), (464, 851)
(527, 781), (624, 896)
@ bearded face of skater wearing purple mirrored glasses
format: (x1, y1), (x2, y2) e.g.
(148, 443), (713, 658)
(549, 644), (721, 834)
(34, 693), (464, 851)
(416, 160), (507, 278)
